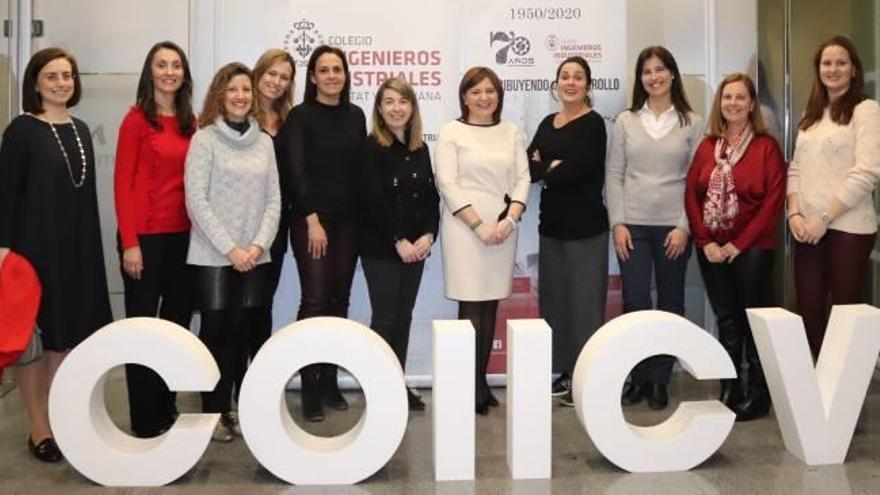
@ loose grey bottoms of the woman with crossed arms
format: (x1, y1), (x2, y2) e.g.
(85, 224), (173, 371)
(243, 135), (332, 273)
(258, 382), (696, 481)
(538, 232), (608, 374)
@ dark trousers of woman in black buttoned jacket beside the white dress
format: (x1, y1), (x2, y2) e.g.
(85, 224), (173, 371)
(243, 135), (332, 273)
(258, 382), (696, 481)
(361, 256), (425, 371)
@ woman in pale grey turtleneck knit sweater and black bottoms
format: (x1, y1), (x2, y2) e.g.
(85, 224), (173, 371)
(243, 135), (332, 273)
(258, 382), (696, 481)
(185, 63), (281, 442)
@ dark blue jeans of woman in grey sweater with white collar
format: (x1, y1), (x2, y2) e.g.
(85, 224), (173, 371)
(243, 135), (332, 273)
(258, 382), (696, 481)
(617, 225), (691, 385)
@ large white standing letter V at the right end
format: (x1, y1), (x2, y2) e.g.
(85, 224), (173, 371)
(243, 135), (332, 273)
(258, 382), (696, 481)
(747, 304), (880, 465)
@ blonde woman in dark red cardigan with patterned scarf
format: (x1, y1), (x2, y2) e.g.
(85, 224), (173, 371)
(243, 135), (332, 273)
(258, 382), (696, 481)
(685, 73), (785, 421)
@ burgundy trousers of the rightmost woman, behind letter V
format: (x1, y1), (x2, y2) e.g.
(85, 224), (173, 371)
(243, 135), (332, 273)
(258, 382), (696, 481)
(794, 230), (877, 359)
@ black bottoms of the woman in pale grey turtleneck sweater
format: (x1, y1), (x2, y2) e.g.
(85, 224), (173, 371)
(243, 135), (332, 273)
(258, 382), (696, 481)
(195, 264), (272, 413)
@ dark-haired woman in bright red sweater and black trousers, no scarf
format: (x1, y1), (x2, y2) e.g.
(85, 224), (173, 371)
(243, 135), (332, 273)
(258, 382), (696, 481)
(114, 41), (195, 437)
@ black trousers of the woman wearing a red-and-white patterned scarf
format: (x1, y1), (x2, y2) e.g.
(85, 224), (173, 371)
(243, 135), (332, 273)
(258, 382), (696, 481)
(697, 248), (773, 391)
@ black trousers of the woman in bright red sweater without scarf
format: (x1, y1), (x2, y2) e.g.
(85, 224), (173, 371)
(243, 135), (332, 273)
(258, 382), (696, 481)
(117, 232), (193, 437)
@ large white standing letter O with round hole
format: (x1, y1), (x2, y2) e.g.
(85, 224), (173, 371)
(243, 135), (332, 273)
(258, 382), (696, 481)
(239, 317), (408, 485)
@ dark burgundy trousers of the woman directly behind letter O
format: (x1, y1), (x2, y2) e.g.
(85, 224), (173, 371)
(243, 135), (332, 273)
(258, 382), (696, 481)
(290, 217), (357, 393)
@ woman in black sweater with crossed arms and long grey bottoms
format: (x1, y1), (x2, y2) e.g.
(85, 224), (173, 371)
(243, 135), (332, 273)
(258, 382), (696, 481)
(528, 57), (608, 406)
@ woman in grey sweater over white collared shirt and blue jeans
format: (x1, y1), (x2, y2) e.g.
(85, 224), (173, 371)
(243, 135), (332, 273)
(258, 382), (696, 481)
(605, 46), (703, 409)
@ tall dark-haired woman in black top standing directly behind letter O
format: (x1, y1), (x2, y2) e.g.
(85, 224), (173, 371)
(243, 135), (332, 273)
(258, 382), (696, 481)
(280, 45), (367, 421)
